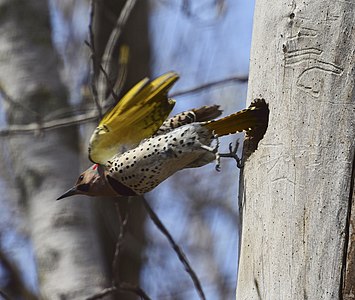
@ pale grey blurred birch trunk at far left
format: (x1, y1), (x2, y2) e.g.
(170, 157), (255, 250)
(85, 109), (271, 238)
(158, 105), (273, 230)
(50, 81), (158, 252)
(0, 0), (105, 299)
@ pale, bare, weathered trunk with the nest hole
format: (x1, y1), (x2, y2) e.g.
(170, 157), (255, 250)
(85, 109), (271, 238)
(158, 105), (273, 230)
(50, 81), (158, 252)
(237, 0), (355, 300)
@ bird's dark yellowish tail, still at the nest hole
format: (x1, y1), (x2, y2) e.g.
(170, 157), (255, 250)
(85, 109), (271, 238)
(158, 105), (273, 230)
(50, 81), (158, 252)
(204, 99), (269, 136)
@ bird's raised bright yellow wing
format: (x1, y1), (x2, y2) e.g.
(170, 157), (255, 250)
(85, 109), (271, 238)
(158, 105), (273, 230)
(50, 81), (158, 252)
(89, 72), (179, 164)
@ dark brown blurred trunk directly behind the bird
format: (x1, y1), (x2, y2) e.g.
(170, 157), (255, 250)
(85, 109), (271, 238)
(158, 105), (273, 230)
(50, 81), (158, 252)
(88, 0), (150, 300)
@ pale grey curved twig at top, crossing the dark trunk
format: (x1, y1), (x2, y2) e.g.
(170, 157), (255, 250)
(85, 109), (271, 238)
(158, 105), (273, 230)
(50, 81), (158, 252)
(98, 0), (137, 99)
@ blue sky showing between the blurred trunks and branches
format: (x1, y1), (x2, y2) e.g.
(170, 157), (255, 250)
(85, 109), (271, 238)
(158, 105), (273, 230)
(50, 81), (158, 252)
(0, 0), (254, 299)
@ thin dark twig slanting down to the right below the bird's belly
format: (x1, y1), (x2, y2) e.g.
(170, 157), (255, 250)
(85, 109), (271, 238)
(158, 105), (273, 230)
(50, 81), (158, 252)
(143, 197), (206, 300)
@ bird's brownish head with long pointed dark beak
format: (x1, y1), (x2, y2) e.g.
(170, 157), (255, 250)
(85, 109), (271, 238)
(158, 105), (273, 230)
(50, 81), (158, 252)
(57, 164), (117, 200)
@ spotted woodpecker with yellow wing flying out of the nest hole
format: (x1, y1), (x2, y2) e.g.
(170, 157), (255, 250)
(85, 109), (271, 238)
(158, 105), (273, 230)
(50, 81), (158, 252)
(57, 72), (268, 200)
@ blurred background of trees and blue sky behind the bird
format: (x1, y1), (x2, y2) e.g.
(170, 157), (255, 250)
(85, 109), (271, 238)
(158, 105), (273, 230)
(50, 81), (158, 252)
(0, 0), (254, 299)
